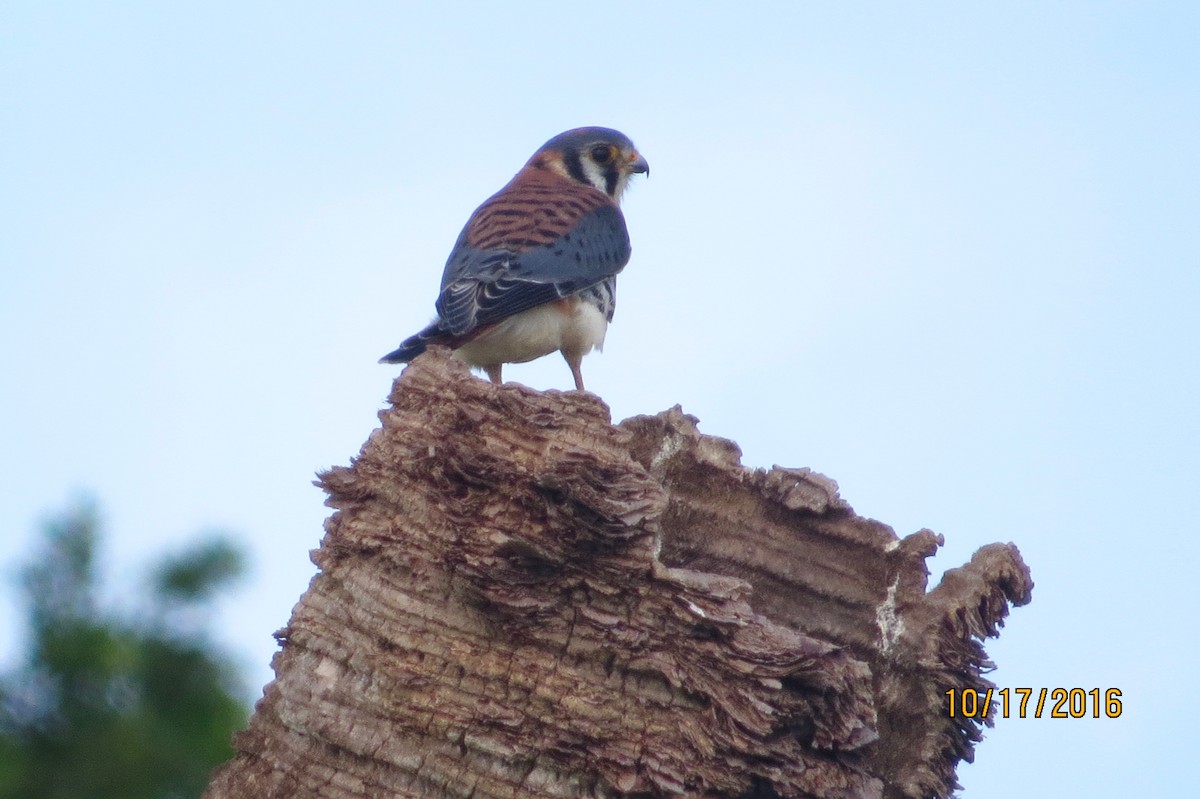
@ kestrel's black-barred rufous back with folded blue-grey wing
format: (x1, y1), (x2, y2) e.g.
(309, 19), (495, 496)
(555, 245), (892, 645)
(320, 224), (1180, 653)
(437, 172), (630, 336)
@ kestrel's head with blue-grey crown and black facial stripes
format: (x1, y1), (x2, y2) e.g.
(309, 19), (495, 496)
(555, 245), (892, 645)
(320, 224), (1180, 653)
(526, 127), (650, 203)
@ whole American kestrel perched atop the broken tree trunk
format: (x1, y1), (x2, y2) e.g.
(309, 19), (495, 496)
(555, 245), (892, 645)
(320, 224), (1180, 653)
(379, 127), (650, 391)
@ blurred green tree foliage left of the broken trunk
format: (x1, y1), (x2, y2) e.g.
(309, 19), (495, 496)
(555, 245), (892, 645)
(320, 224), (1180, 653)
(0, 507), (247, 799)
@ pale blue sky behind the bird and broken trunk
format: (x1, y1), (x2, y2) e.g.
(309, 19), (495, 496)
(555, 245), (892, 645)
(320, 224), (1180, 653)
(0, 2), (1200, 799)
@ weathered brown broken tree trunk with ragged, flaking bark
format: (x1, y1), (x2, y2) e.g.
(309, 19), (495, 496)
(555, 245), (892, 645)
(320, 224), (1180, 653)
(206, 352), (1032, 799)
